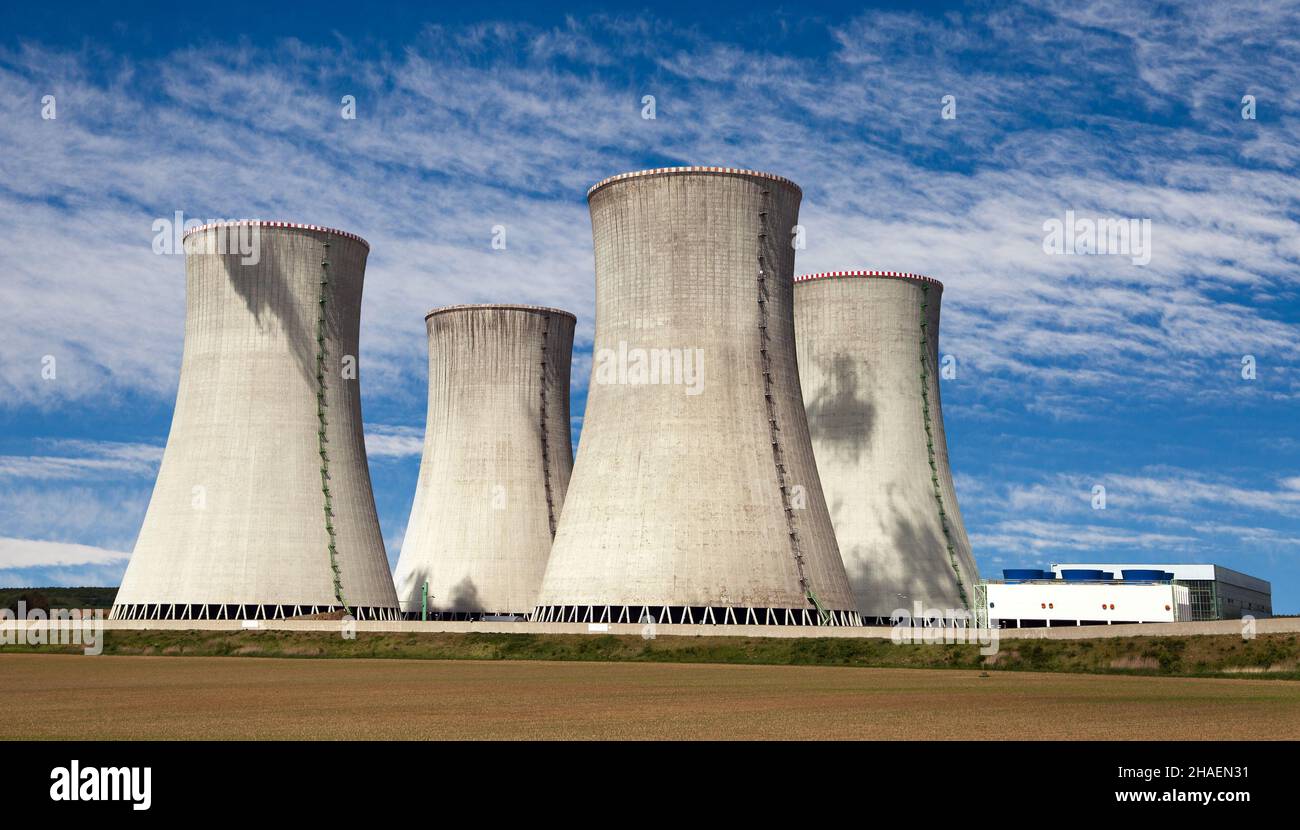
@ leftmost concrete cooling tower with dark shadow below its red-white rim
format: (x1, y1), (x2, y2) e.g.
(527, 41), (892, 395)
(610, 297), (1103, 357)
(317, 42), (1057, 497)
(113, 221), (397, 619)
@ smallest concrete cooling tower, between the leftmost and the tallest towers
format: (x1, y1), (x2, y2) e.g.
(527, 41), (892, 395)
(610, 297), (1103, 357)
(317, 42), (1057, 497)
(397, 306), (575, 619)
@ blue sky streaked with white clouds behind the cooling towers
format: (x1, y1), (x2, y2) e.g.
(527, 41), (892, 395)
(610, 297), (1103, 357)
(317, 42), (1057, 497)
(0, 3), (1300, 613)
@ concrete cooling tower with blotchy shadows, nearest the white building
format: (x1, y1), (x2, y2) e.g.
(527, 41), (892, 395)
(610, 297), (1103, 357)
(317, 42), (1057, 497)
(794, 271), (979, 622)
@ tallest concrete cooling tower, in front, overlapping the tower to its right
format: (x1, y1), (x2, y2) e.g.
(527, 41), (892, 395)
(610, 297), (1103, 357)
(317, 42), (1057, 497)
(534, 167), (858, 626)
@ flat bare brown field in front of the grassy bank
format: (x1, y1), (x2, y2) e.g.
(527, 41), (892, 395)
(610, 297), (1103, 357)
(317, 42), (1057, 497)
(0, 654), (1300, 740)
